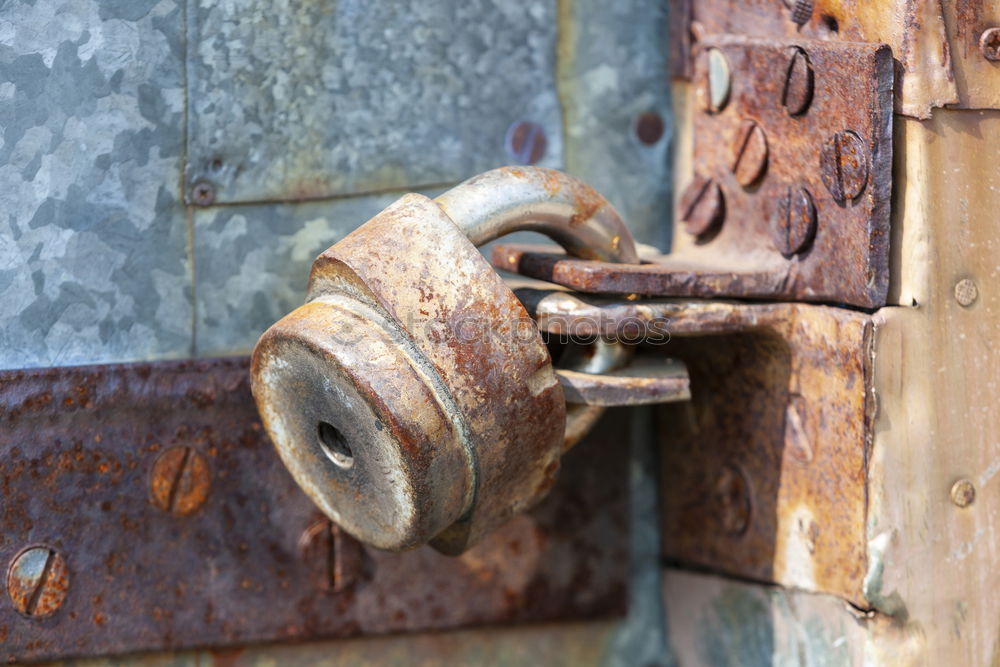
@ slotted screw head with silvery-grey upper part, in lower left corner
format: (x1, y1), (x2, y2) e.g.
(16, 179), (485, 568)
(7, 546), (69, 618)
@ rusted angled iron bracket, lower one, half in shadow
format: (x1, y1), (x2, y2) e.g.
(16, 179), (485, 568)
(517, 289), (874, 607)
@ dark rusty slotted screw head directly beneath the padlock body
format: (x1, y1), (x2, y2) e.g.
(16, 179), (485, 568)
(299, 517), (365, 593)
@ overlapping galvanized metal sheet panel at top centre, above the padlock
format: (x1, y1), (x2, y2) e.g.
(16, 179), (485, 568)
(186, 0), (562, 202)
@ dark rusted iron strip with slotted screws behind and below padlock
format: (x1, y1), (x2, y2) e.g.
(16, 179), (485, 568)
(0, 359), (628, 660)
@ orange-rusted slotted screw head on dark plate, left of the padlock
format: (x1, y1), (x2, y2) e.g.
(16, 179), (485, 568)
(149, 447), (211, 516)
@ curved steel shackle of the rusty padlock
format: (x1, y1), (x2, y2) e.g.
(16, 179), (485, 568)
(434, 167), (639, 264)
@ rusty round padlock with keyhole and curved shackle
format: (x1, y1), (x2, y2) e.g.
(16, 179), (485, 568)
(252, 168), (687, 554)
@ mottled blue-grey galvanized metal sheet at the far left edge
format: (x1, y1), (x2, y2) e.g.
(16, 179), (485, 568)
(0, 0), (192, 367)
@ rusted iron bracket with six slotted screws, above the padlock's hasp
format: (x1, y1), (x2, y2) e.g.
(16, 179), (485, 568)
(493, 37), (892, 308)
